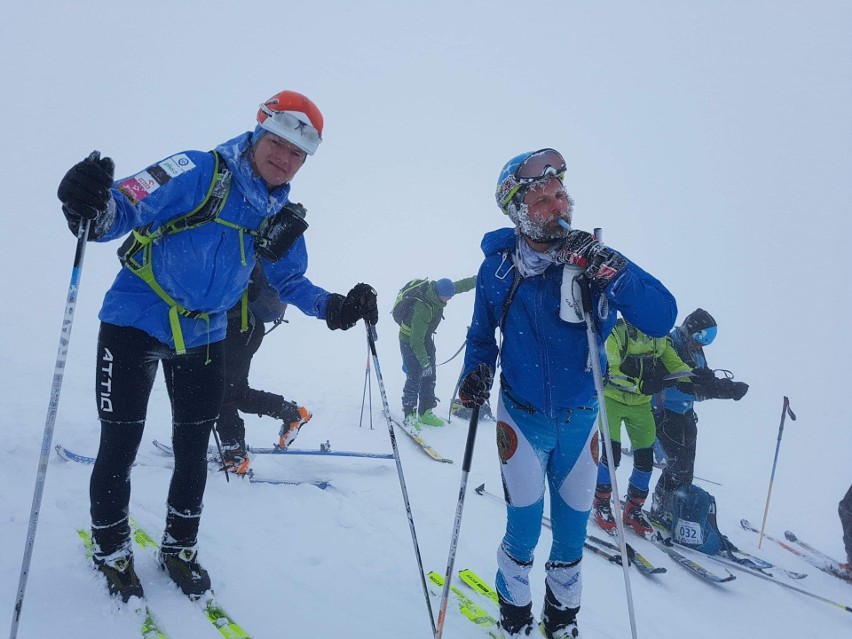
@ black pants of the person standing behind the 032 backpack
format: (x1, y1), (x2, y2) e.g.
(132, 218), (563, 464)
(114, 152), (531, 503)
(654, 410), (698, 492)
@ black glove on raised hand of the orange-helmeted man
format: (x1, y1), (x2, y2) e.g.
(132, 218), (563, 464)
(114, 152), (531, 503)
(56, 151), (115, 239)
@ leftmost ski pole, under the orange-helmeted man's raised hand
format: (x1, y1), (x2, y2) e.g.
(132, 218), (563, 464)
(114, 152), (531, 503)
(9, 151), (101, 639)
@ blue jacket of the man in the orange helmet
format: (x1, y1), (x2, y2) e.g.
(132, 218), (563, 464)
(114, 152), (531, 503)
(98, 132), (331, 348)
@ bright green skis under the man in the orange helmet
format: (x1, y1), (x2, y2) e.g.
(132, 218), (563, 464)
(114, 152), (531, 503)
(77, 517), (251, 639)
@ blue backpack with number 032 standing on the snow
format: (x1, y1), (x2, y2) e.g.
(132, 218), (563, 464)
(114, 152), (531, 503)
(671, 484), (727, 555)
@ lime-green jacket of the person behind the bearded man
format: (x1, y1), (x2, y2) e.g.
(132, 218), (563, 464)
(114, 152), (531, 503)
(604, 320), (692, 406)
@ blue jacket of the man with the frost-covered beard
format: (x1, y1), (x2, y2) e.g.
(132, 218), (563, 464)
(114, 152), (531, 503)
(462, 229), (677, 416)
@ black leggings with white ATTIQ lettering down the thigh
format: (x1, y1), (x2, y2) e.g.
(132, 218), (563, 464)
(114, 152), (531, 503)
(89, 323), (224, 555)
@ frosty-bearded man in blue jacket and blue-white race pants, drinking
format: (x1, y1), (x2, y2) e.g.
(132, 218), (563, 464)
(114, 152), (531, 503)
(459, 149), (677, 639)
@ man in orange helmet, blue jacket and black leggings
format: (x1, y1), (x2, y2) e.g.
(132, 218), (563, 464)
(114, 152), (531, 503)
(58, 91), (378, 601)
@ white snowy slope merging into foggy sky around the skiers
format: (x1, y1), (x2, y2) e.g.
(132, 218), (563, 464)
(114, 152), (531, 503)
(0, 0), (852, 639)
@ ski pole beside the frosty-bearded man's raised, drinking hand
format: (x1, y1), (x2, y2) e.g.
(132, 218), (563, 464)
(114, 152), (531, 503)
(569, 227), (637, 639)
